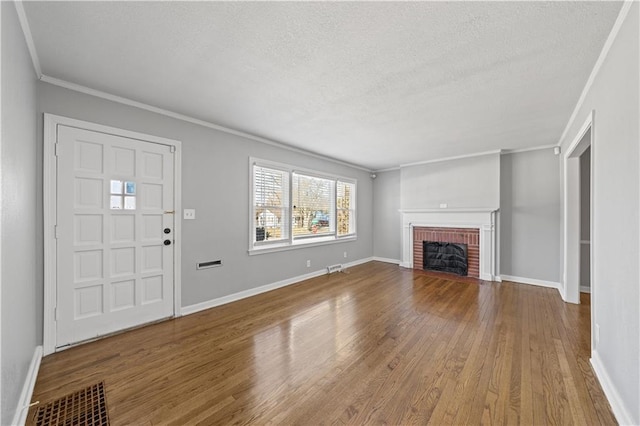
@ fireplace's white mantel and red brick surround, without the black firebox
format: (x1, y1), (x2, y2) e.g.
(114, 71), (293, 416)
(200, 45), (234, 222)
(400, 208), (498, 281)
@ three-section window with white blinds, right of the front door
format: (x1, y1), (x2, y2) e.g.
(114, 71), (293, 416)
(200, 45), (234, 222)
(249, 159), (356, 251)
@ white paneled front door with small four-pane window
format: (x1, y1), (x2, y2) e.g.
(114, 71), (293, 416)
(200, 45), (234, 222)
(55, 125), (175, 348)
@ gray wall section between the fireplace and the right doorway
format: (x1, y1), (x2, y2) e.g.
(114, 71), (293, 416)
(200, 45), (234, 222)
(499, 149), (561, 283)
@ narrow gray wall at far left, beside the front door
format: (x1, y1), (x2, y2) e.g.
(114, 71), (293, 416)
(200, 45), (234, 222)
(0, 2), (42, 425)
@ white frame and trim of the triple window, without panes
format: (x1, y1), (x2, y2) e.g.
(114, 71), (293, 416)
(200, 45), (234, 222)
(249, 157), (357, 255)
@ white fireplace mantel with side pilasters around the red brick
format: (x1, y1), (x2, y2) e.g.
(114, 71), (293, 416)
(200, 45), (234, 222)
(400, 208), (498, 281)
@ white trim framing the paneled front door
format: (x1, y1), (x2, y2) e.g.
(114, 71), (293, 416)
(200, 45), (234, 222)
(42, 113), (182, 355)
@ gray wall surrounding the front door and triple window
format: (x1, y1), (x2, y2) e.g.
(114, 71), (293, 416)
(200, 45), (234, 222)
(38, 83), (373, 306)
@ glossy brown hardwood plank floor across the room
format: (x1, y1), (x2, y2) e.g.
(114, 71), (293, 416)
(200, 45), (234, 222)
(30, 262), (616, 425)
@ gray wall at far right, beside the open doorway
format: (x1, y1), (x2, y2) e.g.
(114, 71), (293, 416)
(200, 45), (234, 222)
(562, 2), (640, 424)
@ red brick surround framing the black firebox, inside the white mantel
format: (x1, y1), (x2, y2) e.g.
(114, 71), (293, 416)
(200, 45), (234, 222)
(413, 226), (480, 278)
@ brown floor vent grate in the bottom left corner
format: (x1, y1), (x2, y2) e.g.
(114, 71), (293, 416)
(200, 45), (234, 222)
(34, 382), (109, 426)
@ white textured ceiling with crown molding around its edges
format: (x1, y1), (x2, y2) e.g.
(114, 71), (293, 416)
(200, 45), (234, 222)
(24, 2), (622, 170)
